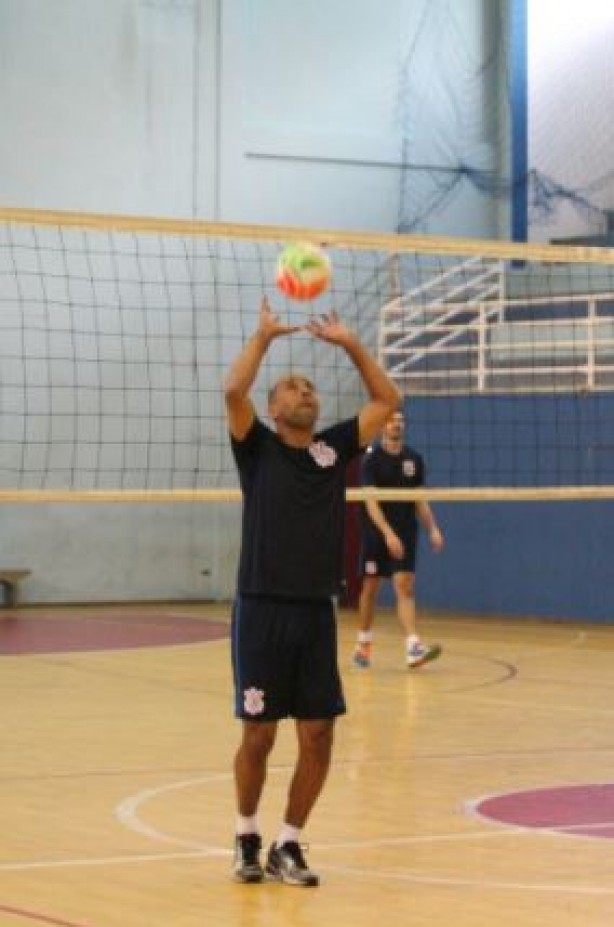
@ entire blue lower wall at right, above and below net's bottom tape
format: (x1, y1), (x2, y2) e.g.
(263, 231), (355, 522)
(402, 394), (614, 623)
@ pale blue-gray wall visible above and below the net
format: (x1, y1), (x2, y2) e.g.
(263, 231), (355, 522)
(0, 0), (510, 602)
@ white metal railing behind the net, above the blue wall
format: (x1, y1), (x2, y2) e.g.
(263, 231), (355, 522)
(379, 289), (614, 394)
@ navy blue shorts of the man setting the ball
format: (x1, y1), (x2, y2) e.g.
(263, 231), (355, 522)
(232, 596), (345, 721)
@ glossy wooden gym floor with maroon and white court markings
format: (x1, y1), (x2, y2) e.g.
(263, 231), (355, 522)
(0, 605), (614, 927)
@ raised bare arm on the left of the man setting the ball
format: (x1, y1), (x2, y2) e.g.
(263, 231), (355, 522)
(224, 296), (298, 441)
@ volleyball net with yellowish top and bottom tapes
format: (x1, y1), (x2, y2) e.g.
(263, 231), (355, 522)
(0, 210), (614, 502)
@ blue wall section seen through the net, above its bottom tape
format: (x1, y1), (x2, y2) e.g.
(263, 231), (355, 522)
(406, 393), (614, 487)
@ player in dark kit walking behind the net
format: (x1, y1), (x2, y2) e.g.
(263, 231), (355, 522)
(353, 410), (444, 669)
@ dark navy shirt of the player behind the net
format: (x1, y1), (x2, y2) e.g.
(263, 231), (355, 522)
(361, 444), (424, 539)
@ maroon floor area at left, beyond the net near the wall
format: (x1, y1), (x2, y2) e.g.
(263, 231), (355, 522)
(0, 609), (228, 656)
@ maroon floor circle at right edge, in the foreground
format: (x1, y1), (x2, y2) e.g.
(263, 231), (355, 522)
(472, 783), (614, 840)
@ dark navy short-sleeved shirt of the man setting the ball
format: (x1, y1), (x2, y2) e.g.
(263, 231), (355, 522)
(231, 418), (360, 599)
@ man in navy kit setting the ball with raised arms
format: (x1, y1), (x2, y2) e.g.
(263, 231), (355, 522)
(224, 299), (400, 886)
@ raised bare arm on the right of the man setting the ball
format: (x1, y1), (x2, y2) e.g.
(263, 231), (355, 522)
(307, 312), (401, 447)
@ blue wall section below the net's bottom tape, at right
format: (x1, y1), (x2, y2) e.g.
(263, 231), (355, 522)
(417, 502), (614, 623)
